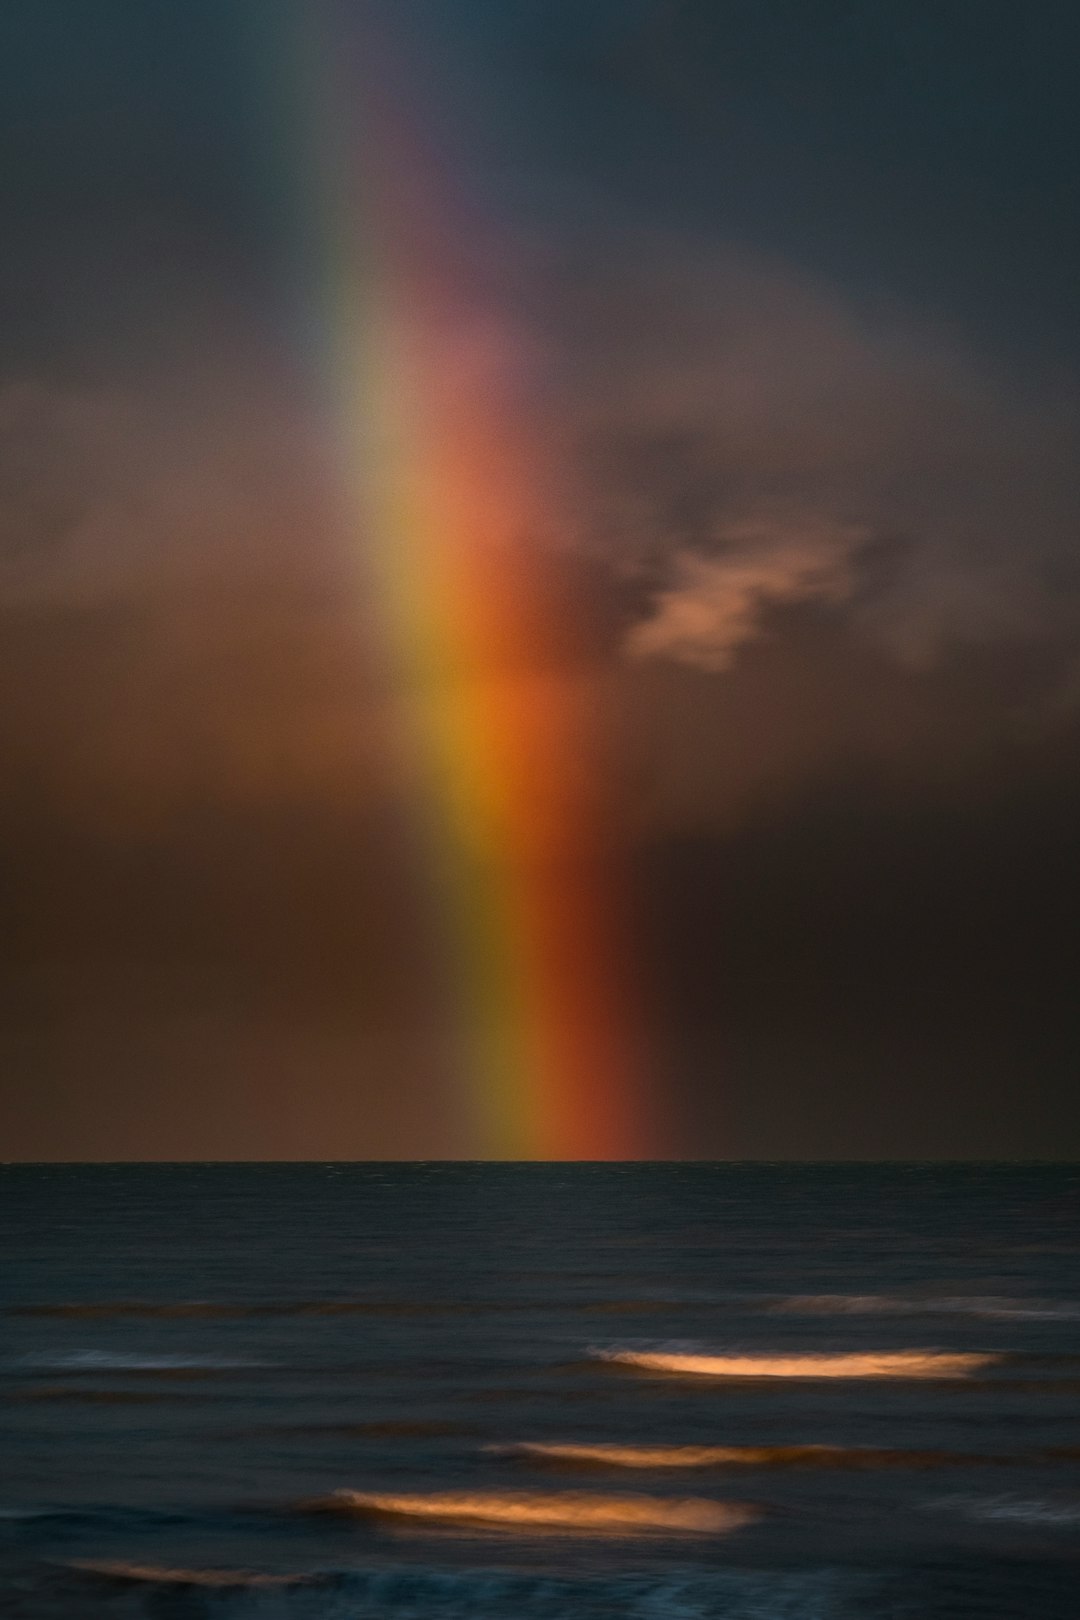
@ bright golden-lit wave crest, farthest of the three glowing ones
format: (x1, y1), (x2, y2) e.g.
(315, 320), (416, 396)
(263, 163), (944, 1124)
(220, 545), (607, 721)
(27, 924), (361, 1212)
(589, 1349), (1001, 1379)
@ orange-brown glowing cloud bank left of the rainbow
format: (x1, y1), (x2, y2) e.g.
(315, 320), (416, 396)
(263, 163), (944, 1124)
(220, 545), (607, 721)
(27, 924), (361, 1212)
(0, 362), (404, 826)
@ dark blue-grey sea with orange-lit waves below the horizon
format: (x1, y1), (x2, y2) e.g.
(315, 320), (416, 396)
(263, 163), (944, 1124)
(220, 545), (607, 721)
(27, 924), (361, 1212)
(0, 1163), (1080, 1620)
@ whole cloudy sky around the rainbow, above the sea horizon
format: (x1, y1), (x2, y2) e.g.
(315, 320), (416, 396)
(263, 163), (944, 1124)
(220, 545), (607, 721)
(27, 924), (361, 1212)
(0, 0), (1080, 1160)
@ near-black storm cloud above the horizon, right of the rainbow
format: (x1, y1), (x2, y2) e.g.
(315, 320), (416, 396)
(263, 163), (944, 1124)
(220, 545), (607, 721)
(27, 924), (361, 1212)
(643, 758), (1080, 1158)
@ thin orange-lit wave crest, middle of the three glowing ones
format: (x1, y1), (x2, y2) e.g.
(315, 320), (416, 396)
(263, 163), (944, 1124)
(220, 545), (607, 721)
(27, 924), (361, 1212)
(486, 1440), (1012, 1468)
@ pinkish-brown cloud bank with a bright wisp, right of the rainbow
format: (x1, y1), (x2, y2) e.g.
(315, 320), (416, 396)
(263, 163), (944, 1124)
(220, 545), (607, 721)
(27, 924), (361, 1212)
(537, 232), (1080, 671)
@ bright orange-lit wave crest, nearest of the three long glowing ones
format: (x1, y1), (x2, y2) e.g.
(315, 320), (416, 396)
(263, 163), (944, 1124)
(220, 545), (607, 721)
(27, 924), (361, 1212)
(301, 1490), (759, 1536)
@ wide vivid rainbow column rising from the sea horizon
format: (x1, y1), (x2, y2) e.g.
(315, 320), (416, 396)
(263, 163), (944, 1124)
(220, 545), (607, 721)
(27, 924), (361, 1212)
(272, 8), (646, 1160)
